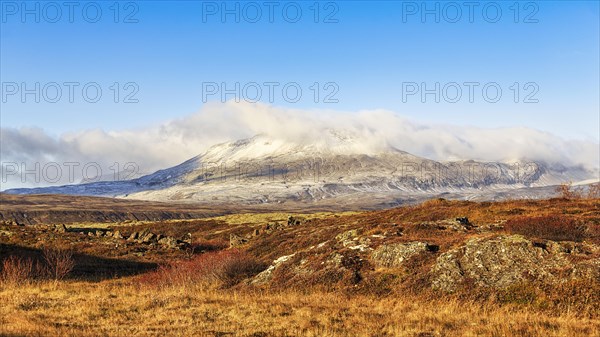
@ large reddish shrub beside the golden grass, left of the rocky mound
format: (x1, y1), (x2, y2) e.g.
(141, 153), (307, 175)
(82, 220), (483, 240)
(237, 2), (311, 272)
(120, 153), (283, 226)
(140, 249), (266, 287)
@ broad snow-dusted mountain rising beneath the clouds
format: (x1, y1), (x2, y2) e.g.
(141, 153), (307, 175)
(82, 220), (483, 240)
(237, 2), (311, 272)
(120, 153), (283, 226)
(5, 130), (598, 208)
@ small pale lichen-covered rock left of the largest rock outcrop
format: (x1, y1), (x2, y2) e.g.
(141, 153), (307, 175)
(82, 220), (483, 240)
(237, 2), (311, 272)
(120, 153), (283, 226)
(371, 242), (437, 268)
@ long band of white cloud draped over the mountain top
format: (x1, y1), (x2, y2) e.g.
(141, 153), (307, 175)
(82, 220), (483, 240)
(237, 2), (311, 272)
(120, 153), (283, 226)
(0, 102), (599, 189)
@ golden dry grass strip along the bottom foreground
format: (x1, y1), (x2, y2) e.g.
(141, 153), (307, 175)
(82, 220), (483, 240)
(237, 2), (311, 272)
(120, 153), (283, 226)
(0, 281), (600, 337)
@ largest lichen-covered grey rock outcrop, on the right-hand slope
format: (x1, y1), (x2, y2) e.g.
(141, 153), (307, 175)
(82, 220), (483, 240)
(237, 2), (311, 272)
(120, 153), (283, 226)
(431, 235), (571, 292)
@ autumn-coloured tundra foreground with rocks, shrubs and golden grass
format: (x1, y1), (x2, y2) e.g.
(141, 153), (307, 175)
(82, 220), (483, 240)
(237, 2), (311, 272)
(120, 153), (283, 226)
(0, 185), (600, 336)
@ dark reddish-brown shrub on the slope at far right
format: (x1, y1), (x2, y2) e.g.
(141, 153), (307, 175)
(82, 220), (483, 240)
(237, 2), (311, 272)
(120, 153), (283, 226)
(504, 215), (585, 242)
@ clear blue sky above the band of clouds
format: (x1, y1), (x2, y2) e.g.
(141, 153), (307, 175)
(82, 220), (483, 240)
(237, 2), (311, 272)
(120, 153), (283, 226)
(0, 1), (600, 142)
